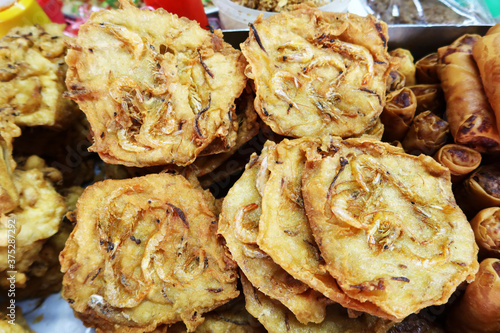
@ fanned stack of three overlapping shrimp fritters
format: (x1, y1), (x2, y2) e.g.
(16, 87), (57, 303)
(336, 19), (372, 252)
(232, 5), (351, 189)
(219, 137), (478, 325)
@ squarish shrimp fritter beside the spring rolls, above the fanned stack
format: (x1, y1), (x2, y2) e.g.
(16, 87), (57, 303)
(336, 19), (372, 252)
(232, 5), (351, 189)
(241, 6), (390, 137)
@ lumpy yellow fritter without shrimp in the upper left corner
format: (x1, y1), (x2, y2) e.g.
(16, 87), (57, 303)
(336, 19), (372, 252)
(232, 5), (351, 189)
(0, 23), (76, 128)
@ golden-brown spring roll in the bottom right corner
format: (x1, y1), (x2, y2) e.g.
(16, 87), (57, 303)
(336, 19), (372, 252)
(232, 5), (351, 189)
(447, 258), (500, 333)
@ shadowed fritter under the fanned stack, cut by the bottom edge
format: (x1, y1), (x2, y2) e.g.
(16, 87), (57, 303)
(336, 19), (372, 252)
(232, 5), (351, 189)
(241, 275), (394, 333)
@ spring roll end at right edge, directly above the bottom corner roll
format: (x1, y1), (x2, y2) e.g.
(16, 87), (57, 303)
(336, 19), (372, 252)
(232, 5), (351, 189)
(470, 207), (500, 259)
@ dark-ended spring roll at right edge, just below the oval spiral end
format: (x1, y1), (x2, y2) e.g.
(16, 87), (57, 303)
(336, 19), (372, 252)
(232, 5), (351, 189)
(455, 163), (500, 217)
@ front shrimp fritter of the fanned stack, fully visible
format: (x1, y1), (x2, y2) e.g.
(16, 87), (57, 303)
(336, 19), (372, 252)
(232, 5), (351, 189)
(302, 139), (478, 319)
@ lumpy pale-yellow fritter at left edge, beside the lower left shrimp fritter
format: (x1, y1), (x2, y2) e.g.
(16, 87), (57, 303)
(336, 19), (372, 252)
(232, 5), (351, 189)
(0, 156), (66, 287)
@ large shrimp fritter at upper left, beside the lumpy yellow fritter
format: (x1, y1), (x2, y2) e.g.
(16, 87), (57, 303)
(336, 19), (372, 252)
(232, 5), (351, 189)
(66, 0), (246, 167)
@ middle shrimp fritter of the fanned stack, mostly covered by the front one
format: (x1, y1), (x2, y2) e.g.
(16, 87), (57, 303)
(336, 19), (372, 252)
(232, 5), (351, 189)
(257, 138), (390, 317)
